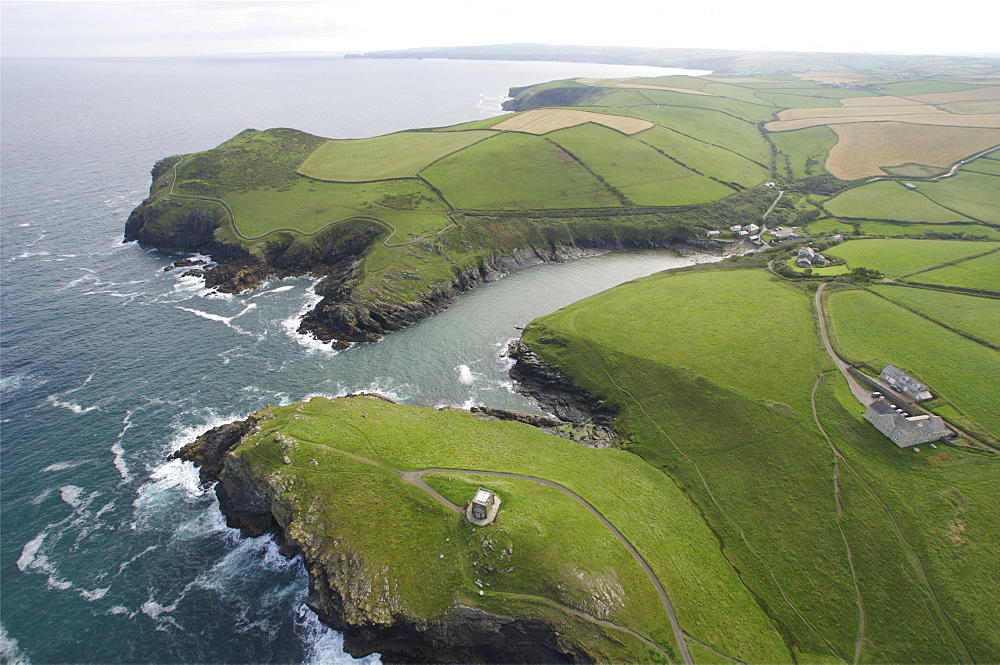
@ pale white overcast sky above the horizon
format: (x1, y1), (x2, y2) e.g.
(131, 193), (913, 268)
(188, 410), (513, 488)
(0, 0), (1000, 57)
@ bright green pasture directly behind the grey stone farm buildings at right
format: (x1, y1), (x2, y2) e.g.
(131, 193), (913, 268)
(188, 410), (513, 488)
(829, 290), (1000, 437)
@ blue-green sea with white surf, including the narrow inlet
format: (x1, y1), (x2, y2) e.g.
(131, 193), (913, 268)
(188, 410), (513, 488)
(0, 58), (707, 663)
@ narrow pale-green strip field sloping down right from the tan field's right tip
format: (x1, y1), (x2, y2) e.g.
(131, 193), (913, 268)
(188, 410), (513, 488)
(635, 127), (768, 187)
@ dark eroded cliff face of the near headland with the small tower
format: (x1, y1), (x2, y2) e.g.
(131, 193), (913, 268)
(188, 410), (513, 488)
(174, 414), (594, 663)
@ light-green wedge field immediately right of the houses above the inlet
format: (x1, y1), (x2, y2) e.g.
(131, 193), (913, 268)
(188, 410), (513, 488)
(826, 238), (1000, 277)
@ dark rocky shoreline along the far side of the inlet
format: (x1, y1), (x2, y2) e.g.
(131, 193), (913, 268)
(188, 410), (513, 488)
(124, 201), (732, 348)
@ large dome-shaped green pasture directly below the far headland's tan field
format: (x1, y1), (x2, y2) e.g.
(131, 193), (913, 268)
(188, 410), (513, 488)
(422, 132), (621, 210)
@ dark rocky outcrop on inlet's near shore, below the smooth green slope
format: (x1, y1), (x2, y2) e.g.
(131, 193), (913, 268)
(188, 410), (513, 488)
(507, 339), (615, 426)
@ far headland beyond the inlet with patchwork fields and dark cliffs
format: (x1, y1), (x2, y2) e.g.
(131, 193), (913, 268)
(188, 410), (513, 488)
(126, 65), (1000, 341)
